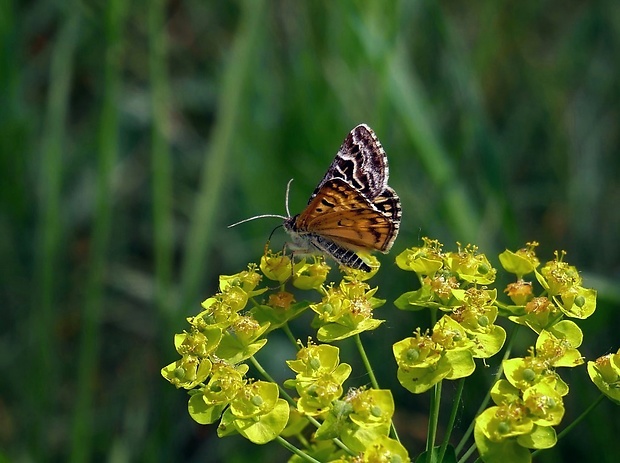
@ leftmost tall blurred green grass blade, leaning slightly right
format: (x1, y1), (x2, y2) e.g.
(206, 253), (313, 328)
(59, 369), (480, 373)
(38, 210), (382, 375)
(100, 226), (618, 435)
(30, 4), (80, 455)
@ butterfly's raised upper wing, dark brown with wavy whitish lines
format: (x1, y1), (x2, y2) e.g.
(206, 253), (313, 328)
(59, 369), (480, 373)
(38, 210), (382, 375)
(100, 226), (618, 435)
(308, 124), (389, 204)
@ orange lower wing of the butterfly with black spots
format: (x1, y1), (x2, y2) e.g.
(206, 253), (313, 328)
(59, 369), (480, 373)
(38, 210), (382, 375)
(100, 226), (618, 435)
(292, 178), (400, 252)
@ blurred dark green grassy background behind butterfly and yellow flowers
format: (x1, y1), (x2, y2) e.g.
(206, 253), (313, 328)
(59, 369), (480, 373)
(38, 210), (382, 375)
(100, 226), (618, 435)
(0, 0), (620, 463)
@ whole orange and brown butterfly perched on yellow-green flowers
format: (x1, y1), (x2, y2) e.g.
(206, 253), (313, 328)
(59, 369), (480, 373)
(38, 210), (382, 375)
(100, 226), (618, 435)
(230, 124), (401, 272)
